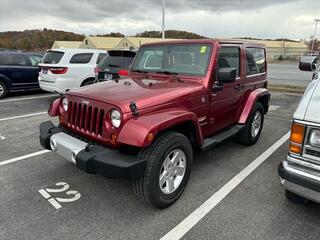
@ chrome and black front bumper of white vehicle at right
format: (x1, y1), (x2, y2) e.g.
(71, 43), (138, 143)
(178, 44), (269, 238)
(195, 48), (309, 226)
(278, 156), (320, 203)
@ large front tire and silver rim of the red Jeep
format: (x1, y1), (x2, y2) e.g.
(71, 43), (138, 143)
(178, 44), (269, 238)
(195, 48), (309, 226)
(133, 131), (193, 209)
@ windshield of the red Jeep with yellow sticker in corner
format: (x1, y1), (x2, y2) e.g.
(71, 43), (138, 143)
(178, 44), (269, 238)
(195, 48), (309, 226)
(132, 44), (211, 76)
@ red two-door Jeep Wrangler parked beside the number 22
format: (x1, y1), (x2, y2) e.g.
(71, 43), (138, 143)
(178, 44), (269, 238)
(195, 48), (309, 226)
(40, 39), (270, 208)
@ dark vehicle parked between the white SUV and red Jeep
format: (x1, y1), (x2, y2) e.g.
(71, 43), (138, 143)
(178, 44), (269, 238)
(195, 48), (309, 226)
(95, 50), (136, 82)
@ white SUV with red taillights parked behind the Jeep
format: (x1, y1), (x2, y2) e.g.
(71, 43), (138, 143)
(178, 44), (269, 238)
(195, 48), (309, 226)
(38, 48), (108, 93)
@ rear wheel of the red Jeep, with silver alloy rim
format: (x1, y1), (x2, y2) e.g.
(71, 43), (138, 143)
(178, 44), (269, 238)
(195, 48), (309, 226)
(237, 102), (264, 145)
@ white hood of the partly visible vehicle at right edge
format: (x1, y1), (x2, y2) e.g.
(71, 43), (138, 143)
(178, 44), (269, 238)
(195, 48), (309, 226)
(294, 79), (320, 123)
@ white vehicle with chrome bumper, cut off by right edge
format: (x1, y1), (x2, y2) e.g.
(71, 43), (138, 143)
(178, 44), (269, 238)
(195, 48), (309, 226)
(278, 56), (320, 203)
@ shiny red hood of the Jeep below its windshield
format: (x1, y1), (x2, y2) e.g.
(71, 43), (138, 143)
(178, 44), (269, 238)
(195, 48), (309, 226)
(66, 78), (204, 113)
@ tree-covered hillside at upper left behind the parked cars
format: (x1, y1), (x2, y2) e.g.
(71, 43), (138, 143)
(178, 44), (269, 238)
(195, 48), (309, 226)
(0, 28), (84, 51)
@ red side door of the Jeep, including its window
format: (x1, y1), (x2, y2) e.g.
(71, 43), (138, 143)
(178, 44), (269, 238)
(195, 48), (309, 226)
(209, 44), (243, 134)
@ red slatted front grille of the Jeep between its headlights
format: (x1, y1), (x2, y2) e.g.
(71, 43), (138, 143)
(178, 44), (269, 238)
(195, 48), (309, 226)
(68, 101), (105, 135)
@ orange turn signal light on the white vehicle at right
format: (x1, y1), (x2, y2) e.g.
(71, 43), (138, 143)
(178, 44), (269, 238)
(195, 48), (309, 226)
(289, 123), (305, 154)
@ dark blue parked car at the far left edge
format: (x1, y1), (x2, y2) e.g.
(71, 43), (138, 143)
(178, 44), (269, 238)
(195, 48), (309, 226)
(0, 50), (42, 98)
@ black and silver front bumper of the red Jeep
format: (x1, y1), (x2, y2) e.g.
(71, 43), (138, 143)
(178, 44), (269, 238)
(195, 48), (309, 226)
(39, 121), (146, 179)
